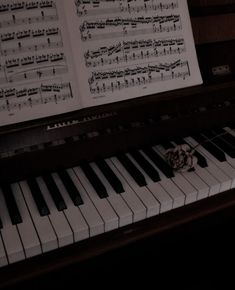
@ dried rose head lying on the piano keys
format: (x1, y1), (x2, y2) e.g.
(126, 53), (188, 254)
(165, 144), (197, 172)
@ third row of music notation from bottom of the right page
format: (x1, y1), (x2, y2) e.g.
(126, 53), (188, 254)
(80, 14), (182, 41)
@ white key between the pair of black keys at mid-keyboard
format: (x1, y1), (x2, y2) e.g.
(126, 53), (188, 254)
(92, 160), (133, 227)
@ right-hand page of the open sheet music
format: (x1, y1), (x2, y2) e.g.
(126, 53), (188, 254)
(64, 0), (202, 106)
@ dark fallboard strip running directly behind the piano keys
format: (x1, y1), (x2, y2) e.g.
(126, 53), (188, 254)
(0, 99), (235, 182)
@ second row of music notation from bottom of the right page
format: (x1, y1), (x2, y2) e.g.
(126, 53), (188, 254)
(84, 38), (186, 67)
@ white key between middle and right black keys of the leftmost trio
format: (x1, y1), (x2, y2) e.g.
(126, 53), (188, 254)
(52, 173), (89, 242)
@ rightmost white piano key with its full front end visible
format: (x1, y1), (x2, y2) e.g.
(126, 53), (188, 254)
(185, 137), (231, 192)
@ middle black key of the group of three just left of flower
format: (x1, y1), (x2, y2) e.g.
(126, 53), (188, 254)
(127, 150), (161, 182)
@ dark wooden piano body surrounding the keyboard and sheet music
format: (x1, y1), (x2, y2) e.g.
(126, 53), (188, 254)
(0, 0), (235, 289)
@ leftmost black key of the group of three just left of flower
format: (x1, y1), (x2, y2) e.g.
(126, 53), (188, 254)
(117, 154), (147, 186)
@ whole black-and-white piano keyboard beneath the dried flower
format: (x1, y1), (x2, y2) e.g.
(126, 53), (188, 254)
(0, 127), (235, 266)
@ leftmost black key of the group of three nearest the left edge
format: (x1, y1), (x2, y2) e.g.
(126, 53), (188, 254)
(27, 178), (50, 216)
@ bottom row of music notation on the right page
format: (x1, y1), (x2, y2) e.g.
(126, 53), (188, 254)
(89, 59), (190, 94)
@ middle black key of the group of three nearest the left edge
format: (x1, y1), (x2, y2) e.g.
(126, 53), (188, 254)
(42, 173), (67, 211)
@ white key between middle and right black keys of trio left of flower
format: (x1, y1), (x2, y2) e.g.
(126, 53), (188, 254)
(140, 148), (185, 208)
